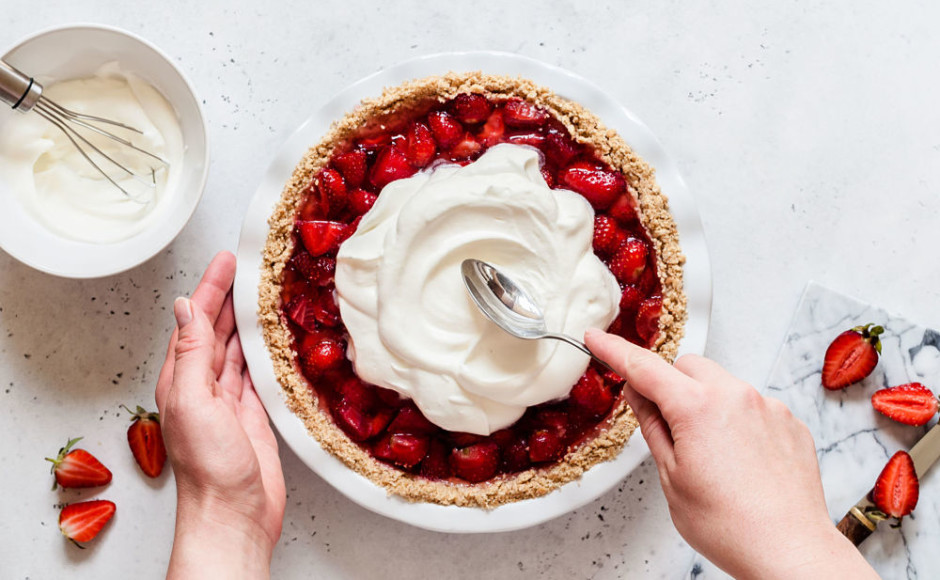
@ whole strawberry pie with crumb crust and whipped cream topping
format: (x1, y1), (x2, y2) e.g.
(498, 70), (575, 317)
(259, 73), (686, 507)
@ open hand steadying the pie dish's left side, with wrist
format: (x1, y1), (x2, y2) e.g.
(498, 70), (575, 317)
(156, 252), (286, 578)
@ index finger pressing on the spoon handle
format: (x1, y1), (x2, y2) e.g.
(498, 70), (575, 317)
(584, 328), (699, 423)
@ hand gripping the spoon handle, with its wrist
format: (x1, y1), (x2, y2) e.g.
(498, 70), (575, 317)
(584, 329), (877, 578)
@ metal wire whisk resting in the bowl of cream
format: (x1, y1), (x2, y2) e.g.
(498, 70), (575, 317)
(0, 60), (170, 200)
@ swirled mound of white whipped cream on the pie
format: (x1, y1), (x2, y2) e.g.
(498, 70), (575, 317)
(336, 144), (620, 435)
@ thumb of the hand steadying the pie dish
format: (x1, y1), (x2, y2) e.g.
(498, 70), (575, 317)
(173, 298), (215, 390)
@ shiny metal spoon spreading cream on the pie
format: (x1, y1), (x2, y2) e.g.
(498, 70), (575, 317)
(460, 258), (617, 373)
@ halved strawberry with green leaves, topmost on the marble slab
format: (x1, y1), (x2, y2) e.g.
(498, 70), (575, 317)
(822, 324), (884, 390)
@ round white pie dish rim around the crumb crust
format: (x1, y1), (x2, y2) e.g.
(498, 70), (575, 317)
(235, 52), (711, 532)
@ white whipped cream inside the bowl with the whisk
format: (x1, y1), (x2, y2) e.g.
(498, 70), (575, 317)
(0, 63), (183, 244)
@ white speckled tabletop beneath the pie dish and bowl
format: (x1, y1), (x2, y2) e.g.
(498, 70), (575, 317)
(0, 0), (940, 579)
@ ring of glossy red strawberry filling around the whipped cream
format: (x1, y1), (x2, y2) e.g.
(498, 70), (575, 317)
(281, 94), (662, 483)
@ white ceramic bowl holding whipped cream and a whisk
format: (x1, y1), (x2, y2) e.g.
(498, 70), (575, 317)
(0, 24), (209, 278)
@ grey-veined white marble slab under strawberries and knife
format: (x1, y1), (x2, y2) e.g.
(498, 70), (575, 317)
(688, 282), (940, 580)
